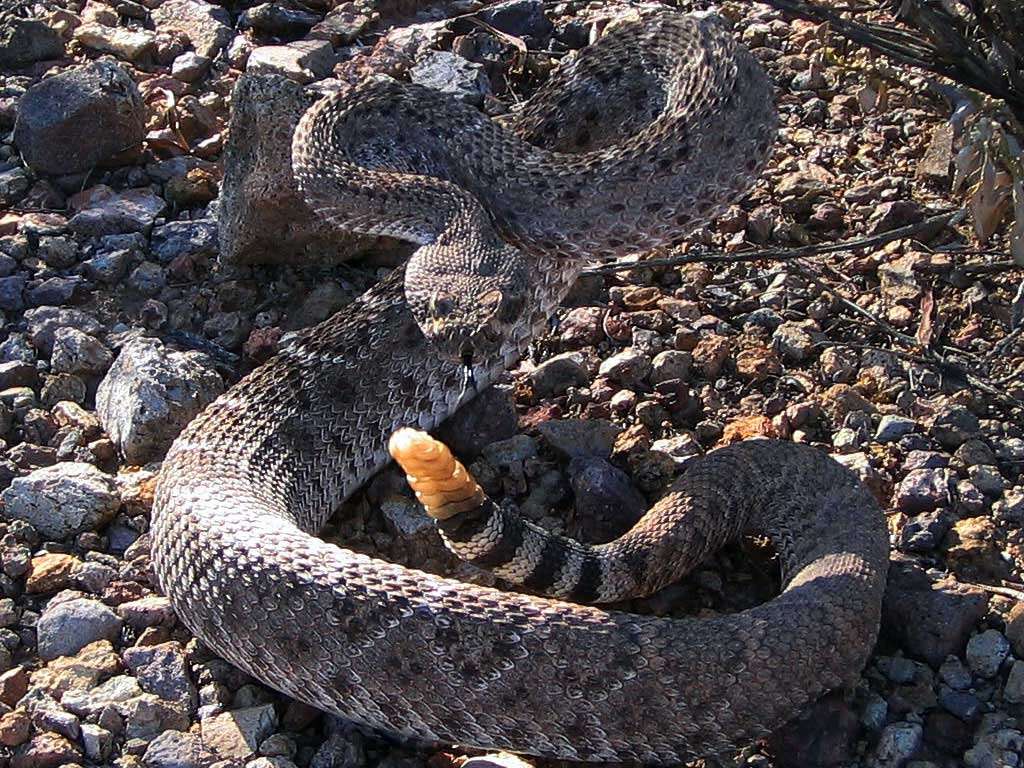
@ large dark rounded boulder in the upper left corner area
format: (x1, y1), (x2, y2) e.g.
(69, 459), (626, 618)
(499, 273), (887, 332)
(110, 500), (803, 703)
(14, 60), (145, 174)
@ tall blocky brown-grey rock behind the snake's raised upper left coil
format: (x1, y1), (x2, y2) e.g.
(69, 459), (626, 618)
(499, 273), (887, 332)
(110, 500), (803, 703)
(218, 74), (411, 264)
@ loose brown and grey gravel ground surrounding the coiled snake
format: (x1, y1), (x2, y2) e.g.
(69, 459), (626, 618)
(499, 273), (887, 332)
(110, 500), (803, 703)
(0, 0), (1024, 768)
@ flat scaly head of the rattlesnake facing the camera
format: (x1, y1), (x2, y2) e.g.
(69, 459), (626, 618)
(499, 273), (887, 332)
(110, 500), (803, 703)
(406, 243), (530, 369)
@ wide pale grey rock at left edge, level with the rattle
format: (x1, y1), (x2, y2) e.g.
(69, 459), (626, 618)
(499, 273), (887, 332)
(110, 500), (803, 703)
(0, 462), (121, 541)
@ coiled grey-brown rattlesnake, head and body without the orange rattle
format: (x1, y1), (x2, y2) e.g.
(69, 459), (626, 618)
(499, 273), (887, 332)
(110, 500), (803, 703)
(152, 10), (887, 763)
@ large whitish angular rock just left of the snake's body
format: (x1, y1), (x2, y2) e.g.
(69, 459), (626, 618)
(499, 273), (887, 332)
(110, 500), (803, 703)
(96, 338), (223, 464)
